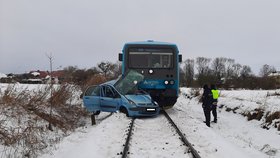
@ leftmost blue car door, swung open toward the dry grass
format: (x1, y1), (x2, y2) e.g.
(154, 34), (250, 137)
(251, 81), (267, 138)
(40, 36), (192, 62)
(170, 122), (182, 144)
(83, 86), (101, 112)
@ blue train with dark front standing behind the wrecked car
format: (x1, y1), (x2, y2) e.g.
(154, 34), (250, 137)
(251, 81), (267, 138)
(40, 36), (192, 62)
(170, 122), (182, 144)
(119, 40), (182, 109)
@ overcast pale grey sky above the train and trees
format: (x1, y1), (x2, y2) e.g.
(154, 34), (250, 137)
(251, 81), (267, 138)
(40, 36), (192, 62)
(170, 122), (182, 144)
(0, 0), (280, 74)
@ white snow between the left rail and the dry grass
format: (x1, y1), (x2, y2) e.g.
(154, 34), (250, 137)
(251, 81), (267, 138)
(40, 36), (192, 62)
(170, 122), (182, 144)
(42, 113), (130, 158)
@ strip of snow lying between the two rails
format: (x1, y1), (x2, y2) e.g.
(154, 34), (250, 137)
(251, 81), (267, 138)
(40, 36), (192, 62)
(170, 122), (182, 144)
(129, 115), (188, 158)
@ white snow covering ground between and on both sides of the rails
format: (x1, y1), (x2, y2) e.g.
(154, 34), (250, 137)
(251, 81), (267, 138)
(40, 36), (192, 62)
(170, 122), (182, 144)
(0, 84), (280, 158)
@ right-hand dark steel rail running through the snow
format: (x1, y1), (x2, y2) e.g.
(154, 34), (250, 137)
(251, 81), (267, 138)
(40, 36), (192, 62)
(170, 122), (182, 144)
(162, 110), (201, 158)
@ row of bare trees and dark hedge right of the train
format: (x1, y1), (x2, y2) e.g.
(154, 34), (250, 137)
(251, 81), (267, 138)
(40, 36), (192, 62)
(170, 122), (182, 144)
(180, 57), (279, 89)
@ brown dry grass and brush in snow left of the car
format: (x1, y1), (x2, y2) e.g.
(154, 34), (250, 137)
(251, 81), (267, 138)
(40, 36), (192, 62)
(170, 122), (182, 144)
(0, 84), (88, 157)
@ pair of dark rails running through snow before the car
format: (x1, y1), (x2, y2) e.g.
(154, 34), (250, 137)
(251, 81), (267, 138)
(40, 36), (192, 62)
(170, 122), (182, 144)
(122, 110), (200, 158)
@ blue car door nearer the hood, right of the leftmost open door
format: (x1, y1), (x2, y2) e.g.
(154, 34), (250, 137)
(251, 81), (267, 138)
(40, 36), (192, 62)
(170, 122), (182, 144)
(100, 85), (121, 112)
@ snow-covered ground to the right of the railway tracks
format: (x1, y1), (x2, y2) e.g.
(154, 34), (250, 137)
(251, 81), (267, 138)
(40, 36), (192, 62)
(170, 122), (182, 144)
(171, 89), (280, 158)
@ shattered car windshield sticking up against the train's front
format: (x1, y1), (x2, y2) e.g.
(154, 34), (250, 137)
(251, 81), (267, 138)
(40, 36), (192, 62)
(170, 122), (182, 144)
(114, 70), (144, 95)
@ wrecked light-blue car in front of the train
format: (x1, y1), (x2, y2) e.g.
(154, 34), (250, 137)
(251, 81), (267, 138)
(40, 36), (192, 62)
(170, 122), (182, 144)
(83, 70), (160, 117)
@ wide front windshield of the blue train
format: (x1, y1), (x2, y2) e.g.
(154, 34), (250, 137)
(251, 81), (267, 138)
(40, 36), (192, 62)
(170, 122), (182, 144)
(128, 48), (174, 68)
